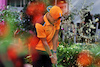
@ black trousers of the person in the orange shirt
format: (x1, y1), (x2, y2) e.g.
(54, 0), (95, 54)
(33, 51), (52, 67)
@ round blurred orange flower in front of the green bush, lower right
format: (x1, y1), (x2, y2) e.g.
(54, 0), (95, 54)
(77, 51), (93, 67)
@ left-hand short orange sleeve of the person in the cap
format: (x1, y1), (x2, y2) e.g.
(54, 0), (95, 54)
(35, 23), (46, 38)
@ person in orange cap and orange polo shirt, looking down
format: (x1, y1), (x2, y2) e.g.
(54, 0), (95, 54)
(32, 6), (62, 67)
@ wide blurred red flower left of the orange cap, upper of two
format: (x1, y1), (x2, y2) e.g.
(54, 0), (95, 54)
(26, 2), (46, 16)
